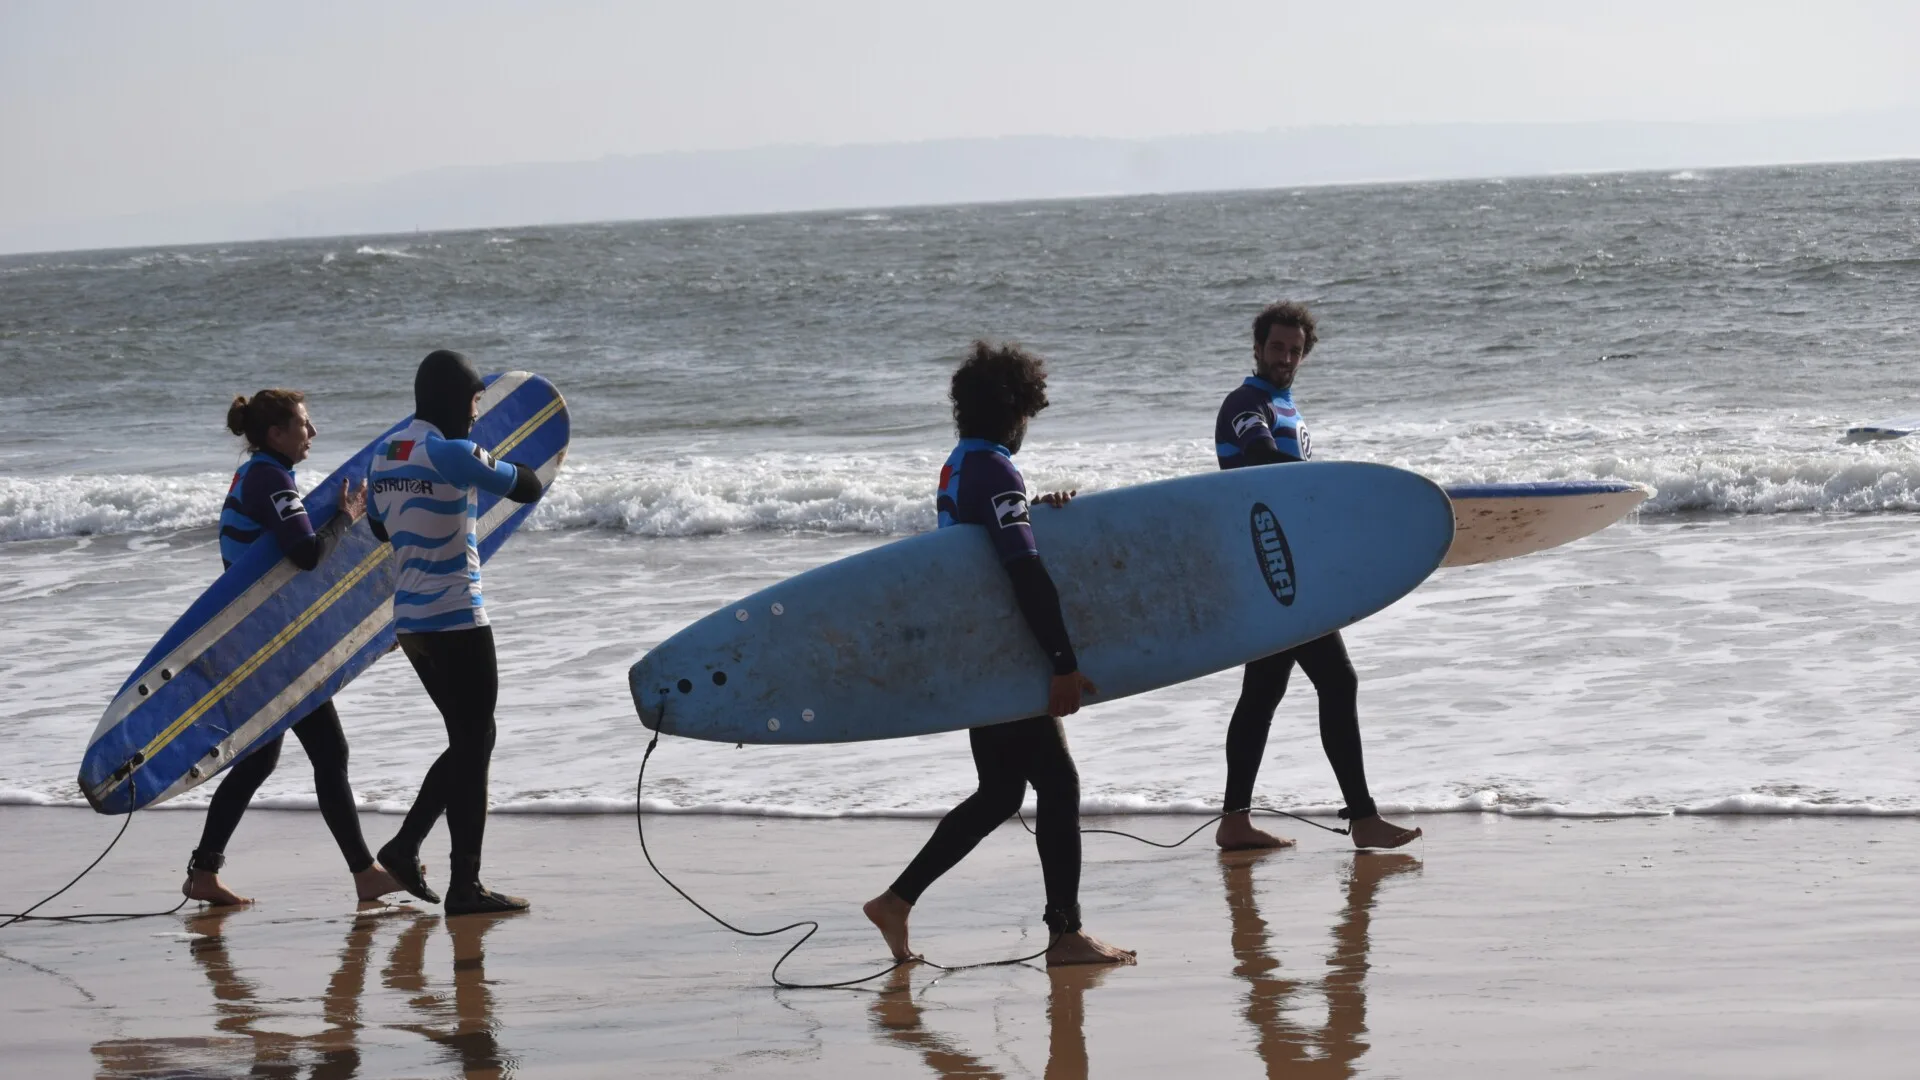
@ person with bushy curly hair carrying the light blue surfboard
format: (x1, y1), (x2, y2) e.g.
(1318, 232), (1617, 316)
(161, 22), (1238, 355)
(864, 342), (1133, 967)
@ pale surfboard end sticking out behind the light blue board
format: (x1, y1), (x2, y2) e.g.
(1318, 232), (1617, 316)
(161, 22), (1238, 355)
(1440, 480), (1653, 567)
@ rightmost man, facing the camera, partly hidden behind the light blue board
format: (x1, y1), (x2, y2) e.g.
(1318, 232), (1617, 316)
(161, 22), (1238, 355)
(1213, 302), (1421, 849)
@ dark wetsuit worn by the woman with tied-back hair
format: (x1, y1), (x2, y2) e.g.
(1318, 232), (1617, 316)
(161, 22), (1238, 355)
(192, 452), (372, 874)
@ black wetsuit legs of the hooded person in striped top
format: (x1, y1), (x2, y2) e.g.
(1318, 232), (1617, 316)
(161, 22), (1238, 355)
(394, 626), (499, 884)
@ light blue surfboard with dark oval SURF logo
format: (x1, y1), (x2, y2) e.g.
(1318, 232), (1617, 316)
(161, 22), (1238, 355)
(628, 461), (1453, 744)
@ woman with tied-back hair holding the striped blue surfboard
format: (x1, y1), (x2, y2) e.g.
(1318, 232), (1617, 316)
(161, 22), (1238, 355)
(180, 390), (399, 903)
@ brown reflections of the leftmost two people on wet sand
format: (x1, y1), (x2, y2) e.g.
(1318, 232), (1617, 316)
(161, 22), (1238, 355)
(94, 903), (515, 1080)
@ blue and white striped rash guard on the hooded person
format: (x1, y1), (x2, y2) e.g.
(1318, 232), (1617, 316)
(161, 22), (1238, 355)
(367, 419), (516, 634)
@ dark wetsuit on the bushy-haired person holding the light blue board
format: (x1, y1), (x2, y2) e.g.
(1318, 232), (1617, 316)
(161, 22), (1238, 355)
(893, 438), (1081, 934)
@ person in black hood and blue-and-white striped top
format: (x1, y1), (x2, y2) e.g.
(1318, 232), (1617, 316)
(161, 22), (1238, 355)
(367, 350), (541, 915)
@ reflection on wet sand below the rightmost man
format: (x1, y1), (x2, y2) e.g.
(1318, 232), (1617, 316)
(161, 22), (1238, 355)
(1219, 851), (1421, 1080)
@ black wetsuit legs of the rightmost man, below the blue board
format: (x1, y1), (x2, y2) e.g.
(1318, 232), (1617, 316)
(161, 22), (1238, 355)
(1225, 632), (1375, 819)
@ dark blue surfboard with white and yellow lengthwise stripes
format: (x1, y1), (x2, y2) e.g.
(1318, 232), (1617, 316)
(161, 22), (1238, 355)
(79, 371), (568, 813)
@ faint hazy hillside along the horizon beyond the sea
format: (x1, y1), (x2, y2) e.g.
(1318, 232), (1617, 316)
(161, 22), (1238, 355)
(0, 110), (1920, 252)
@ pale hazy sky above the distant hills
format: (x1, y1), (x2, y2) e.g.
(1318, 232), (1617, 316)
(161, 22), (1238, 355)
(11, 0), (1920, 225)
